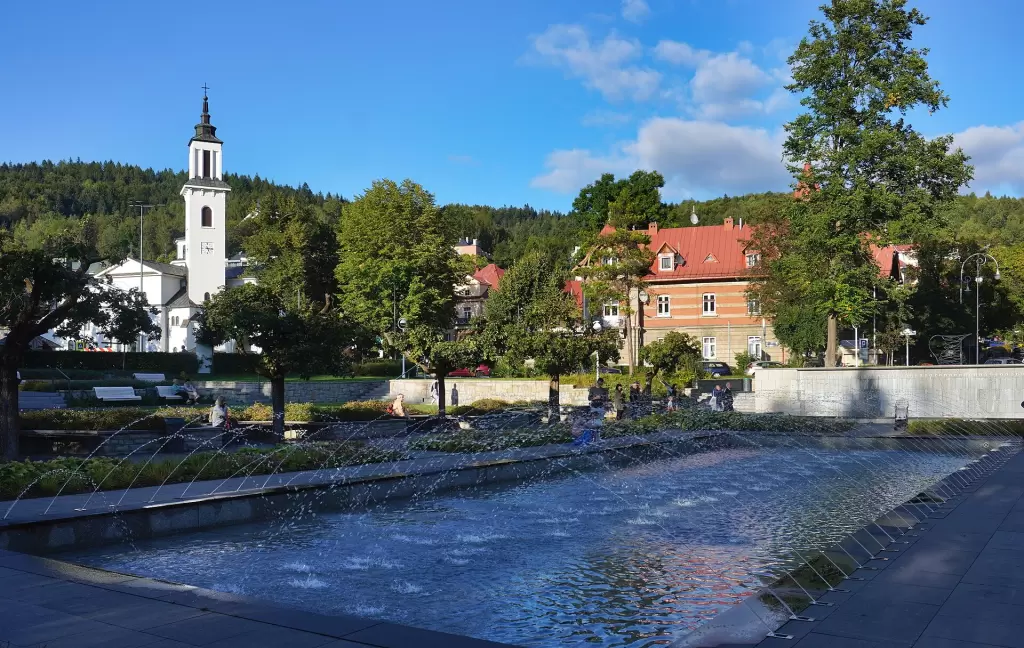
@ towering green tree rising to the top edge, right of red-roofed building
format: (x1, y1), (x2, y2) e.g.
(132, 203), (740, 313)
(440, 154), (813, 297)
(755, 0), (972, 366)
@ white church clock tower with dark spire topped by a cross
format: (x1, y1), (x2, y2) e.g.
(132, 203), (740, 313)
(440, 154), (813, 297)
(181, 86), (231, 304)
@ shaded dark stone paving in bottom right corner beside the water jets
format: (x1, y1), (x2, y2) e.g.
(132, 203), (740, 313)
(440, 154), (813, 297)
(757, 444), (1024, 648)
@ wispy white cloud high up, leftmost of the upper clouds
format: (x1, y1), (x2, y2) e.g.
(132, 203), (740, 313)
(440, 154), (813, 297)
(527, 25), (662, 101)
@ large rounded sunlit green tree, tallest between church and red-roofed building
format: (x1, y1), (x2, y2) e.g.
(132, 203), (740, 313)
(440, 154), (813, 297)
(335, 180), (470, 361)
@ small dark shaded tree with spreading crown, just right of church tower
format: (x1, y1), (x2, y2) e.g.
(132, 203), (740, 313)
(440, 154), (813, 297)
(198, 284), (355, 438)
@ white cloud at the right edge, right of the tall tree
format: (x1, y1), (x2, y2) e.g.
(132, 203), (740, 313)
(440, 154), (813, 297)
(953, 122), (1024, 195)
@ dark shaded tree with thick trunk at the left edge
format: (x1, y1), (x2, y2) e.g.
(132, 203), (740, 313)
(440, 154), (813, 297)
(0, 217), (160, 460)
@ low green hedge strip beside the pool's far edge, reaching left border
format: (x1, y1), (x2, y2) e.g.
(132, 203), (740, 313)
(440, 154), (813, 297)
(0, 441), (402, 500)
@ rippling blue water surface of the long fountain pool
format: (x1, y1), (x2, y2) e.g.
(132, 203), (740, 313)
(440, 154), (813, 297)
(71, 439), (978, 647)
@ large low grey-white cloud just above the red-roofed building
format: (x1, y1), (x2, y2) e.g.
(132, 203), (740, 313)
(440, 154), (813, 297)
(530, 118), (790, 197)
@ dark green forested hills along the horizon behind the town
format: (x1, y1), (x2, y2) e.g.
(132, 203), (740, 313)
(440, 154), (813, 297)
(0, 161), (1024, 267)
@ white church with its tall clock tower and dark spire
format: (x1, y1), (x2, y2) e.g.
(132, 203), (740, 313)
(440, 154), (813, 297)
(71, 94), (255, 352)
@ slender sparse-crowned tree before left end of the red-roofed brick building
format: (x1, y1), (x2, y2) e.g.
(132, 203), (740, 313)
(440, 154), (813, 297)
(577, 229), (654, 376)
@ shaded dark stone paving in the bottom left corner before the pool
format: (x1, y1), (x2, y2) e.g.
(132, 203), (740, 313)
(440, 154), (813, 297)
(0, 551), (509, 648)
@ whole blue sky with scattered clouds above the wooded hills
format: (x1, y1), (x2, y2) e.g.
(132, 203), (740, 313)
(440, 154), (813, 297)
(0, 0), (1024, 210)
